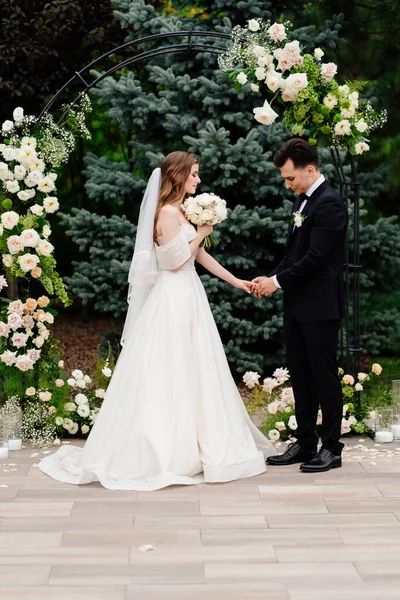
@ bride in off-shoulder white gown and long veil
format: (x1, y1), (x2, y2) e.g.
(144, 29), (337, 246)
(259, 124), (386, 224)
(39, 152), (275, 490)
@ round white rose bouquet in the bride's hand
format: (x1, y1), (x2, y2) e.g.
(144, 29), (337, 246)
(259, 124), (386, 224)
(182, 192), (228, 248)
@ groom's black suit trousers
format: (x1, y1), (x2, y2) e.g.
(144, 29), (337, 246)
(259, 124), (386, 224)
(284, 312), (343, 455)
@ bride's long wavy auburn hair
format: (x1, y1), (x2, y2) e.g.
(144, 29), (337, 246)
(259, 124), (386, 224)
(154, 152), (199, 238)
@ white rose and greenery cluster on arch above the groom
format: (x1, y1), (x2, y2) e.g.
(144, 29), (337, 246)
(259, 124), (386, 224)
(218, 19), (387, 154)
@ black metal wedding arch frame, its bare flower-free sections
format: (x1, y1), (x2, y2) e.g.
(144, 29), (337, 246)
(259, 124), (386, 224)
(35, 29), (361, 374)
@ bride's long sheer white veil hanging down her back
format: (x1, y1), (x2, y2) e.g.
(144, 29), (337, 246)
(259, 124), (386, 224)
(121, 168), (161, 346)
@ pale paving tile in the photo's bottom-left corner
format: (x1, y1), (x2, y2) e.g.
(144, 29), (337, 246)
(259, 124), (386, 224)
(1, 585), (125, 600)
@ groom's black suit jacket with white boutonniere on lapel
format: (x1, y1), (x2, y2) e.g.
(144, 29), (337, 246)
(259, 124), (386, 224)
(269, 181), (348, 323)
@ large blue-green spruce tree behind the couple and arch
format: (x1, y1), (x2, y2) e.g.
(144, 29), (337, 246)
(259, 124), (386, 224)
(63, 0), (400, 375)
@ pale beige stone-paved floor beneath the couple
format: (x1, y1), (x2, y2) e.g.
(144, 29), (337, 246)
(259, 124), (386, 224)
(0, 438), (400, 600)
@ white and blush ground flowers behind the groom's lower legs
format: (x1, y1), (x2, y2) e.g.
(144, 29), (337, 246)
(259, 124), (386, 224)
(243, 363), (382, 441)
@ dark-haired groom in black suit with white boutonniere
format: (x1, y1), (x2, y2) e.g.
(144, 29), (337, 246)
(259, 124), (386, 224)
(253, 138), (348, 473)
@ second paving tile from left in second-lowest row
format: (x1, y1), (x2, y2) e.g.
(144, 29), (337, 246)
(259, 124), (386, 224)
(49, 565), (205, 584)
